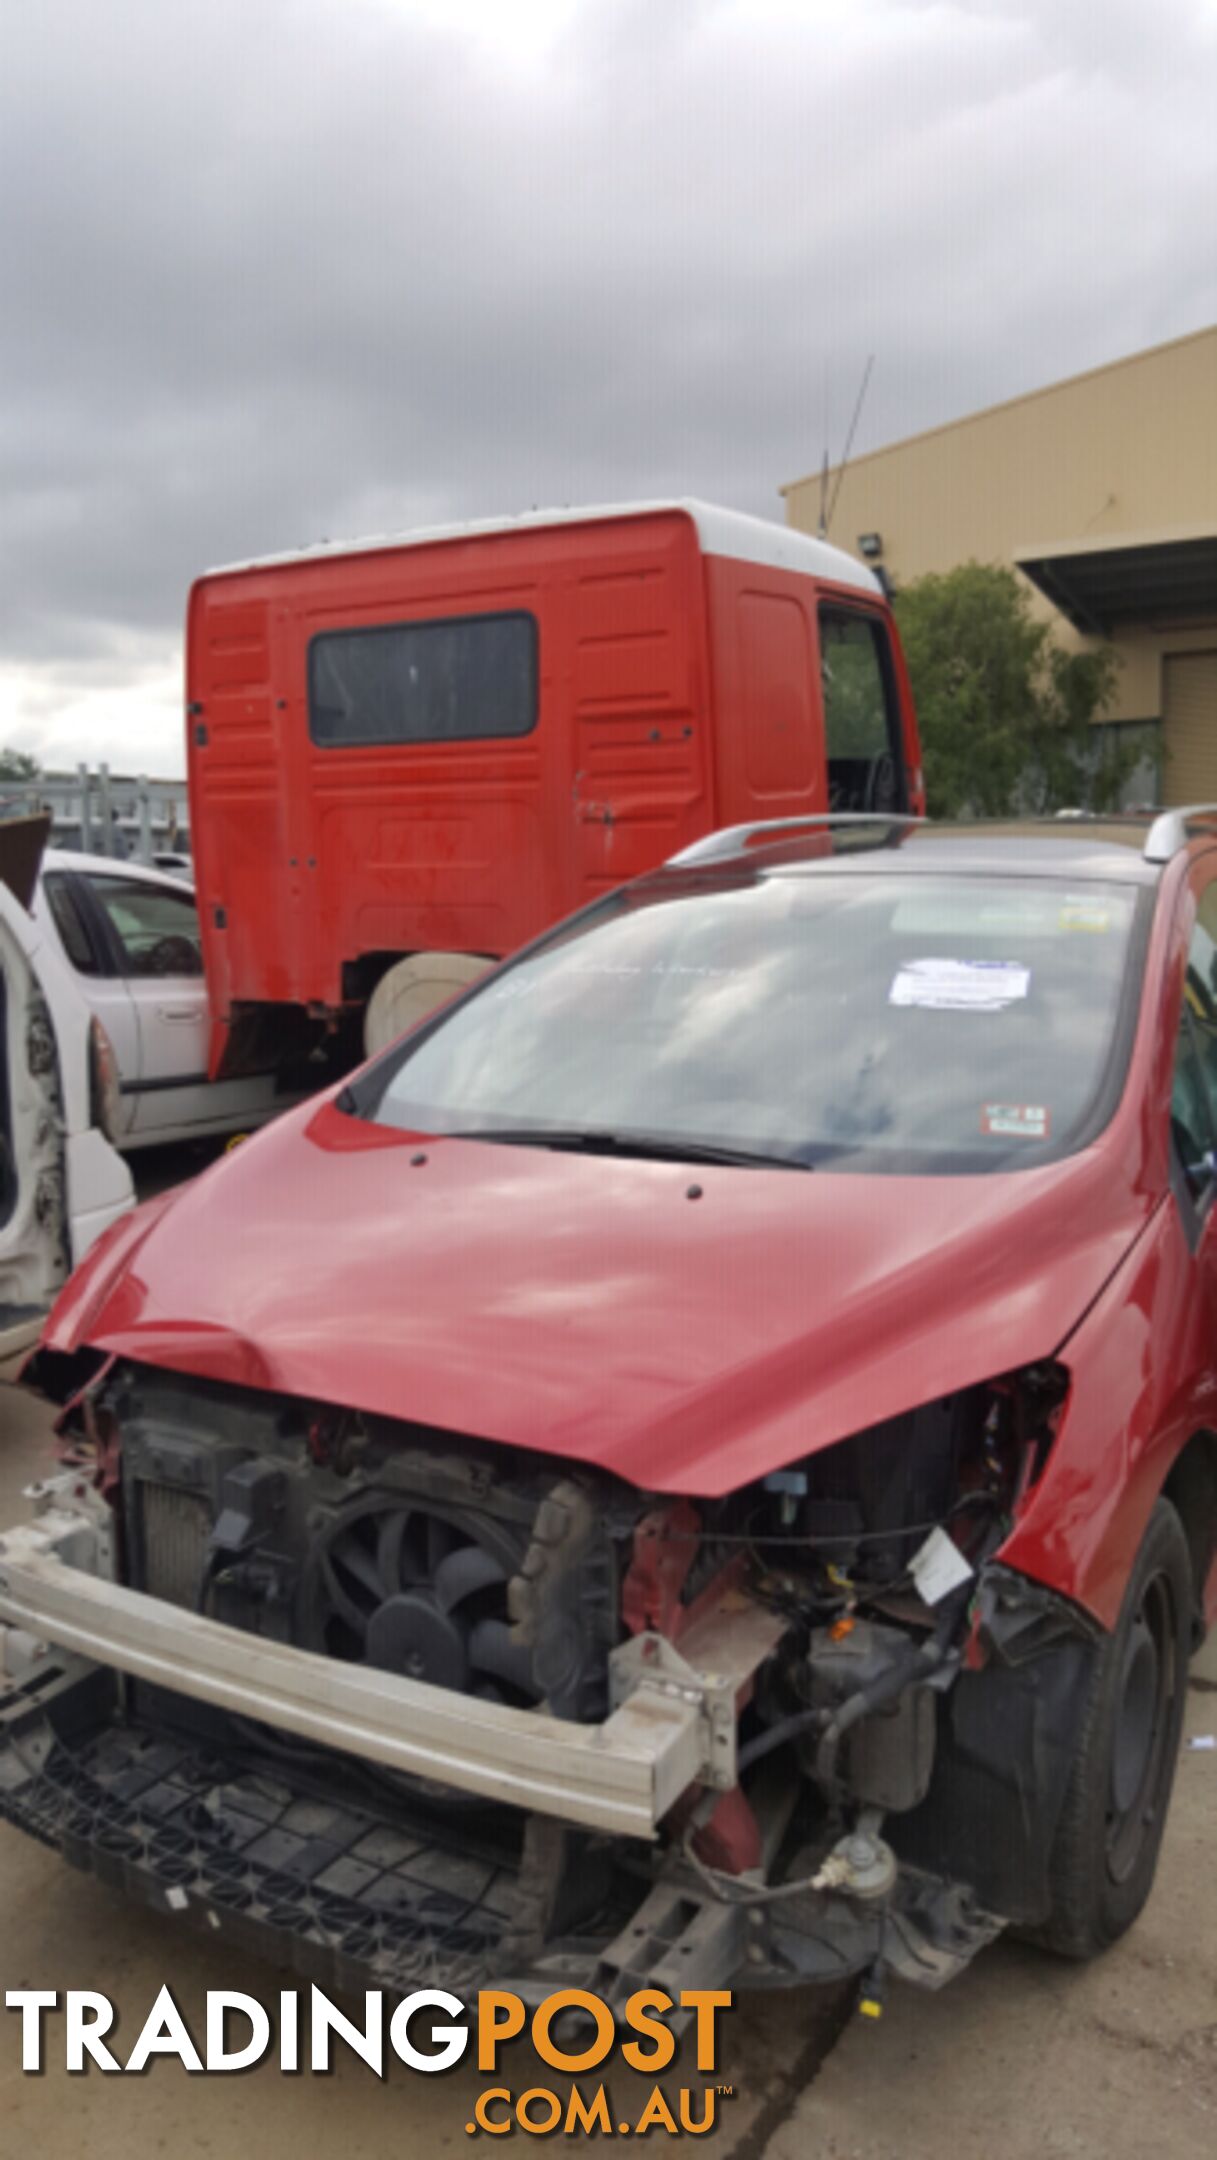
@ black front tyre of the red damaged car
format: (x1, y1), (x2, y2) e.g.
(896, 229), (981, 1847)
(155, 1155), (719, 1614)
(1035, 1499), (1191, 1957)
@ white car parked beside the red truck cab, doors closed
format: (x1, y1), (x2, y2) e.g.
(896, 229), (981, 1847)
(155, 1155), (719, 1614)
(35, 849), (292, 1153)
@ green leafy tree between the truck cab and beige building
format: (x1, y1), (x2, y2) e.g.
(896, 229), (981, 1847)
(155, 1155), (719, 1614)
(895, 562), (1144, 816)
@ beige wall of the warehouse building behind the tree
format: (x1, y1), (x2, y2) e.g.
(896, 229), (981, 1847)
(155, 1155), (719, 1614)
(780, 326), (1217, 768)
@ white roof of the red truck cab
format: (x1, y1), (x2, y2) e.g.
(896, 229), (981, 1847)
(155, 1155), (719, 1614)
(205, 497), (882, 594)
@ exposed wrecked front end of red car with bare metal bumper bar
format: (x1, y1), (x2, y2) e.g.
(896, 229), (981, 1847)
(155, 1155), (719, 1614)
(0, 1352), (1094, 2000)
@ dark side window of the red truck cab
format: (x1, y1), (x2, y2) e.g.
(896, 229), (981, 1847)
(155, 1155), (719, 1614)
(819, 607), (908, 812)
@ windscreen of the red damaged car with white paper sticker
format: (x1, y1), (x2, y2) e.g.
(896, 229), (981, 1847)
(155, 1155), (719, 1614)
(361, 870), (1137, 1173)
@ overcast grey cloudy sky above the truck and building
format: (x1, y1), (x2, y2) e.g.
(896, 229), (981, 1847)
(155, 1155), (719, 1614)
(0, 0), (1217, 773)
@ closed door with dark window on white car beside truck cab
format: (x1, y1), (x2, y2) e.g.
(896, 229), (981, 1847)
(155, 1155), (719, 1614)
(78, 866), (214, 1138)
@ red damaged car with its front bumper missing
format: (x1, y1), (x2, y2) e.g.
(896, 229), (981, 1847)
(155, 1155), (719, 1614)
(0, 812), (1217, 1998)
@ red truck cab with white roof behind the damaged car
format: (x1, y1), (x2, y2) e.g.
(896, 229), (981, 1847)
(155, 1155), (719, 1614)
(186, 503), (921, 1074)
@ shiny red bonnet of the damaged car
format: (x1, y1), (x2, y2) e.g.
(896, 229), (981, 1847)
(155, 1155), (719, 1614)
(42, 1088), (1148, 1497)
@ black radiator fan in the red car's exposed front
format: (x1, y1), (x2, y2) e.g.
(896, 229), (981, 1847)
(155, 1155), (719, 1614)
(303, 1493), (540, 1706)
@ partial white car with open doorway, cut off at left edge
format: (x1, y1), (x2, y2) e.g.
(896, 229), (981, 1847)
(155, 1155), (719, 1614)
(0, 819), (134, 1361)
